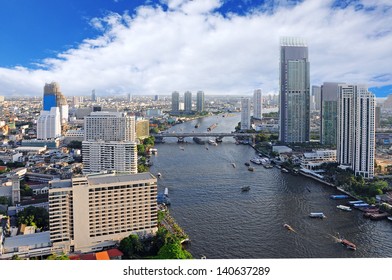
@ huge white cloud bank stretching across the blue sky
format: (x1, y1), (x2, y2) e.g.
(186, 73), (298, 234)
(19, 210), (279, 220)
(0, 0), (392, 96)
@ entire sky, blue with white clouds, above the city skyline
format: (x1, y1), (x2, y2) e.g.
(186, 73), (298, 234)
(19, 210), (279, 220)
(0, 0), (392, 97)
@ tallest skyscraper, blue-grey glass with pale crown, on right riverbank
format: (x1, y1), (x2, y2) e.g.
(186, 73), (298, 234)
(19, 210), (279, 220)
(279, 37), (310, 143)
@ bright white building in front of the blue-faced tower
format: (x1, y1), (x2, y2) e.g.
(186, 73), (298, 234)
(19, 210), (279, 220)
(37, 107), (61, 140)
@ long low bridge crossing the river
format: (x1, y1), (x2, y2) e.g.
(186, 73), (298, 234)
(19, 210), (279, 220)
(151, 132), (257, 142)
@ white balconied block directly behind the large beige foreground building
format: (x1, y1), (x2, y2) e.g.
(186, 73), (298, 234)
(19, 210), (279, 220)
(82, 141), (137, 174)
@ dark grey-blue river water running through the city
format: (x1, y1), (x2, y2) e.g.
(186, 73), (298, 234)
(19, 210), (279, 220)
(150, 114), (392, 259)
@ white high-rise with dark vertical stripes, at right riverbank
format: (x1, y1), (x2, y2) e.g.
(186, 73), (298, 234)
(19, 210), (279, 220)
(337, 84), (375, 179)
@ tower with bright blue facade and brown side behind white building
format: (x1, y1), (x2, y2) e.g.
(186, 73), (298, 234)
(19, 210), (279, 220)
(42, 82), (69, 123)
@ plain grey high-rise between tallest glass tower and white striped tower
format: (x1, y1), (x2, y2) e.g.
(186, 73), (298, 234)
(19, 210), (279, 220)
(320, 83), (339, 146)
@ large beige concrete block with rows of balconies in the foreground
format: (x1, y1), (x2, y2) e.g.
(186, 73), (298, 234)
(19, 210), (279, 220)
(49, 173), (157, 253)
